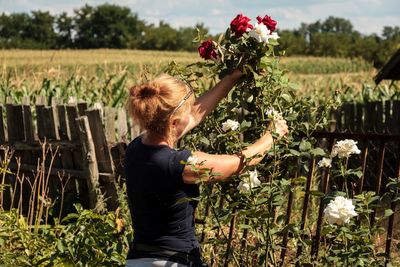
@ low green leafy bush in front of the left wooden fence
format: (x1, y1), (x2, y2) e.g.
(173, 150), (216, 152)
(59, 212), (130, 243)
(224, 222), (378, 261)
(0, 205), (132, 266)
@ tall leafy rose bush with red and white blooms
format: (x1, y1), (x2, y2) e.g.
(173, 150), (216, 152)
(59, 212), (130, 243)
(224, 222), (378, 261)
(168, 14), (394, 266)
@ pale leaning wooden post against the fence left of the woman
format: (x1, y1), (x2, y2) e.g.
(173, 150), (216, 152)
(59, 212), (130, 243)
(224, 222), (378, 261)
(77, 116), (105, 211)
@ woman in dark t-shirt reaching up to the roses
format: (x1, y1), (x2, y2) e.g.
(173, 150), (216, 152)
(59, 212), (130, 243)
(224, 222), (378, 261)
(125, 71), (288, 267)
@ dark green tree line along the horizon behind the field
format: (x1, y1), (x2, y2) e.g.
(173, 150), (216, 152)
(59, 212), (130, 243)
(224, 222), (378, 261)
(0, 4), (400, 66)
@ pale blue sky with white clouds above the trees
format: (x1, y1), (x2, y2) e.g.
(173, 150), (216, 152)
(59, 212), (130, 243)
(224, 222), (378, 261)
(0, 0), (400, 34)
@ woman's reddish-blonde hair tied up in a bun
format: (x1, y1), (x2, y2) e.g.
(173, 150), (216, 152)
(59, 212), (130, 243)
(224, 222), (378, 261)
(127, 74), (193, 138)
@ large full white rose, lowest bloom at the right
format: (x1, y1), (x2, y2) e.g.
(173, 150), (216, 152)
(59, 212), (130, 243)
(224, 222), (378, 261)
(324, 196), (358, 225)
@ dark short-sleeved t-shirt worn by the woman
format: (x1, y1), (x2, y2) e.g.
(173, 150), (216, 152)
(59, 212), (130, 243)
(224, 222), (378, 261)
(125, 136), (199, 252)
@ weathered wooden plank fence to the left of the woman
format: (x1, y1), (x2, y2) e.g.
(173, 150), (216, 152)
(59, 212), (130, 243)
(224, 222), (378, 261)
(0, 97), (138, 216)
